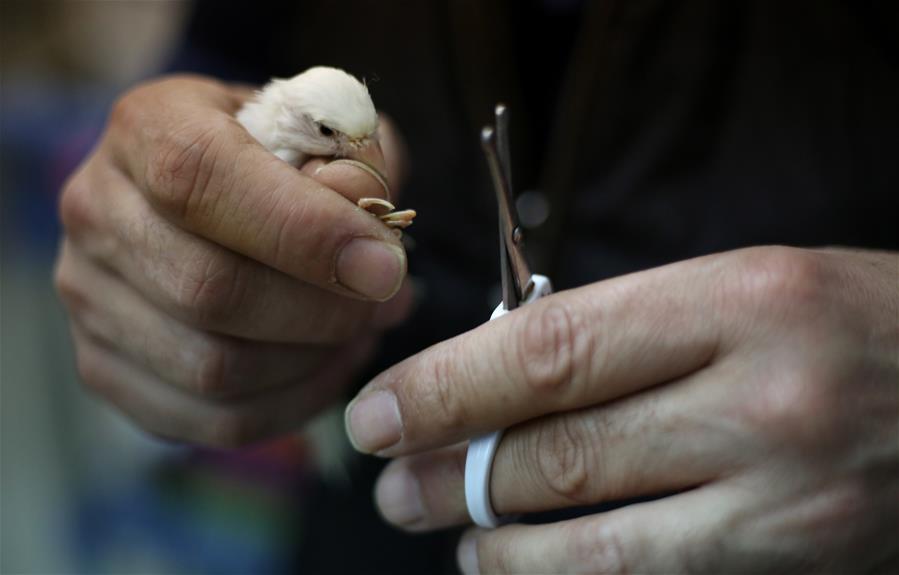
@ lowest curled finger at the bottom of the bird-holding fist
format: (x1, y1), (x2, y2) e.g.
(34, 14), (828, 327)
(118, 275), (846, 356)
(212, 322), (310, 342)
(72, 324), (371, 447)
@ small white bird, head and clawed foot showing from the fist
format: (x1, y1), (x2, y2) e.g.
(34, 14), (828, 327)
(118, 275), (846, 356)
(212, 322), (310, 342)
(237, 66), (415, 229)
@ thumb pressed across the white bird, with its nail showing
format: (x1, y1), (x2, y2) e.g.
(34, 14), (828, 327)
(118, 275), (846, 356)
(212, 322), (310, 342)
(110, 79), (406, 300)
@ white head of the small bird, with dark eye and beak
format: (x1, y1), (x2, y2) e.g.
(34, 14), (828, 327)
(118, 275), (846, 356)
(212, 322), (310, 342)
(260, 66), (380, 165)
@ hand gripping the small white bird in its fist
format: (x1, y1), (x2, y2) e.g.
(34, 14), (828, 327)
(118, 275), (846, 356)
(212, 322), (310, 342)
(55, 77), (411, 446)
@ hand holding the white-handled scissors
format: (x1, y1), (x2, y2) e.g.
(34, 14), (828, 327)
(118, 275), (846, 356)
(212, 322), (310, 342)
(347, 247), (899, 573)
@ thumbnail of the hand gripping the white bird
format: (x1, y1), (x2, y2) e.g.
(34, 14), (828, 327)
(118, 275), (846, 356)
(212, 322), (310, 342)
(335, 238), (406, 301)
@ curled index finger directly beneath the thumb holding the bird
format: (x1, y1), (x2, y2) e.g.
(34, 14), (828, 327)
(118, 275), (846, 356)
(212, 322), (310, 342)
(61, 160), (390, 343)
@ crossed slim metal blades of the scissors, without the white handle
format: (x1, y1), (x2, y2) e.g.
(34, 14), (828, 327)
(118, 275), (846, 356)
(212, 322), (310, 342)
(481, 105), (532, 310)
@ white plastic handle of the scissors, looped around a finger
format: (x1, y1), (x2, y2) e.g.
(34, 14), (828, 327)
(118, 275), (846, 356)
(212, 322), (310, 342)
(465, 274), (553, 529)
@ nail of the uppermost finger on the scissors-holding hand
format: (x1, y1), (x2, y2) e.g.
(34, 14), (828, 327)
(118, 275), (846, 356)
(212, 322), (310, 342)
(345, 391), (403, 453)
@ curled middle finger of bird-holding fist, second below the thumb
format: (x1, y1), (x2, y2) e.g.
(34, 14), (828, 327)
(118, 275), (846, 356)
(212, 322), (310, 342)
(58, 242), (327, 396)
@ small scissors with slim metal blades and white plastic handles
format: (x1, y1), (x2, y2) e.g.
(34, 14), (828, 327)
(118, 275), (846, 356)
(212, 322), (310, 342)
(465, 104), (552, 528)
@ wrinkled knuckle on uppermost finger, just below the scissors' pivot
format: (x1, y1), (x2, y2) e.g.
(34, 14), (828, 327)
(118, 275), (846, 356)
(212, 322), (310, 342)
(512, 302), (592, 395)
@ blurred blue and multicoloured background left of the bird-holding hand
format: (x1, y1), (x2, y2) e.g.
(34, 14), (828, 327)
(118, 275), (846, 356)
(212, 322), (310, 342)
(0, 0), (324, 575)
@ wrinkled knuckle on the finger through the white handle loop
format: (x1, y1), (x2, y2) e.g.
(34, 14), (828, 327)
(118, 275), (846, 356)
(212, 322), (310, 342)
(524, 417), (595, 504)
